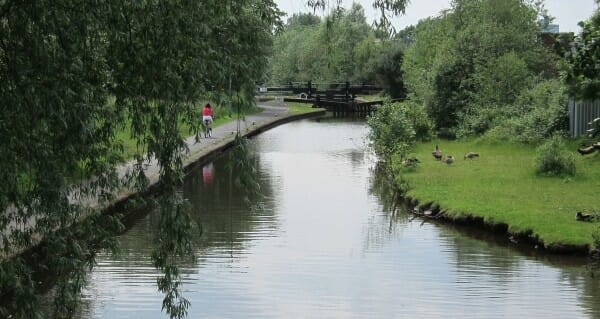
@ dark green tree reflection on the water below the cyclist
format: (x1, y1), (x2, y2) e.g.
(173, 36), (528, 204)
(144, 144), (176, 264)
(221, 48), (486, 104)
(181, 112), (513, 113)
(183, 135), (277, 255)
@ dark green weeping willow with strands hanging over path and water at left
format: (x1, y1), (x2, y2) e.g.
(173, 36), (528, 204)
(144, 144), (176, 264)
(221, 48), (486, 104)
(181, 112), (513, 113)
(0, 0), (281, 317)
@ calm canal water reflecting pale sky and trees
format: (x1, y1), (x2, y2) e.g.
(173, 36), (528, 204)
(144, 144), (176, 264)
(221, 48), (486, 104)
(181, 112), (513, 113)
(69, 119), (600, 319)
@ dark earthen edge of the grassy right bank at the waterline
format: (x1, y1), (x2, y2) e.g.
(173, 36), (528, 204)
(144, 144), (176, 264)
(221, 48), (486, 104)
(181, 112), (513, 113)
(394, 195), (600, 258)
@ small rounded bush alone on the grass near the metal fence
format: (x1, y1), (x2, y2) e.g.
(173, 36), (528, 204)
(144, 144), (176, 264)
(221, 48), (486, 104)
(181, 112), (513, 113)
(536, 134), (575, 176)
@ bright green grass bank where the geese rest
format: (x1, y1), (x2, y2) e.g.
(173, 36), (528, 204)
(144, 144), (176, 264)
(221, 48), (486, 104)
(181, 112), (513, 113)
(402, 141), (600, 250)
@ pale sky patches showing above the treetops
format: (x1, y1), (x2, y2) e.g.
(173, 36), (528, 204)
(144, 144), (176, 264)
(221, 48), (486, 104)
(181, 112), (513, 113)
(275, 0), (597, 33)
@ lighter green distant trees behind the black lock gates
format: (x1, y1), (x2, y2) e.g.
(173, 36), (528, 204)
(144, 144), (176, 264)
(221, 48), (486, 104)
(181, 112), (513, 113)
(270, 4), (410, 97)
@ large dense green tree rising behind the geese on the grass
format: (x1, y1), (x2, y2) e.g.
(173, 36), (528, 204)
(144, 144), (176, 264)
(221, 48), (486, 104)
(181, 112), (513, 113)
(403, 0), (554, 137)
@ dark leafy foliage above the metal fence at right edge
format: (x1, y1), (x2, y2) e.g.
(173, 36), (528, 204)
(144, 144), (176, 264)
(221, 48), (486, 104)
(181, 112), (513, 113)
(566, 5), (600, 100)
